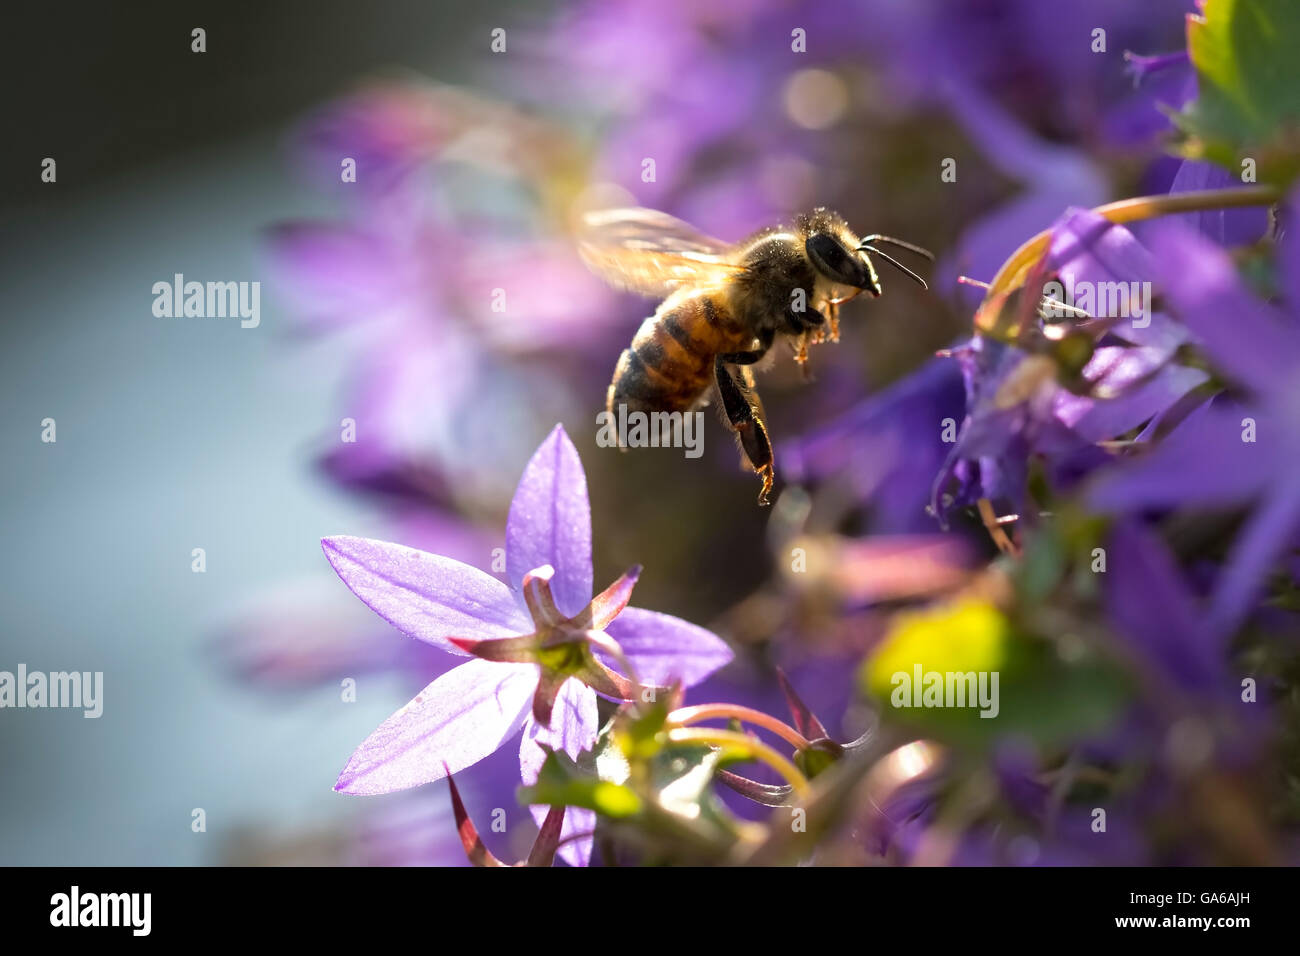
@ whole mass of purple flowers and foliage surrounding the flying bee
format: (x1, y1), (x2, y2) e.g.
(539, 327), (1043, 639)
(226, 0), (1300, 865)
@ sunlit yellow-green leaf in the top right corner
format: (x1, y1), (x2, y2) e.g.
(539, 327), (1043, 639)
(1175, 0), (1300, 183)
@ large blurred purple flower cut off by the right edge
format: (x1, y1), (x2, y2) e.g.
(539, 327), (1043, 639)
(1089, 196), (1300, 632)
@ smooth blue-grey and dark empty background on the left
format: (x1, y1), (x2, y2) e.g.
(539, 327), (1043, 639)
(0, 3), (523, 865)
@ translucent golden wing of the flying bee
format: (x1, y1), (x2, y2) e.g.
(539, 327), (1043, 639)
(579, 208), (745, 298)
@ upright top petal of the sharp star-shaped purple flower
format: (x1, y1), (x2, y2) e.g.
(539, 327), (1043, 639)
(506, 425), (592, 615)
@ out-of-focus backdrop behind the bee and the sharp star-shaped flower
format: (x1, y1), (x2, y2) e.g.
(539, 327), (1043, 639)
(0, 0), (1191, 865)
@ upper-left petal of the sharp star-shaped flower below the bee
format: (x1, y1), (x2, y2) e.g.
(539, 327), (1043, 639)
(321, 535), (532, 654)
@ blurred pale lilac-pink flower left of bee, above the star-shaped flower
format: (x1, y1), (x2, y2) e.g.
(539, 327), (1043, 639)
(272, 208), (592, 505)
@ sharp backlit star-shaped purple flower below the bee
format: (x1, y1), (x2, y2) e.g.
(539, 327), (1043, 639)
(321, 425), (732, 865)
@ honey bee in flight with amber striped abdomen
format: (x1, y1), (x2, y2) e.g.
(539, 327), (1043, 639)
(579, 208), (933, 505)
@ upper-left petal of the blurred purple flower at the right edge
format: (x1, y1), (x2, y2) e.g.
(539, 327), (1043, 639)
(1152, 224), (1300, 392)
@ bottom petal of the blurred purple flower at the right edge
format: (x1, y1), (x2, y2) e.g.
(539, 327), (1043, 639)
(1210, 486), (1300, 633)
